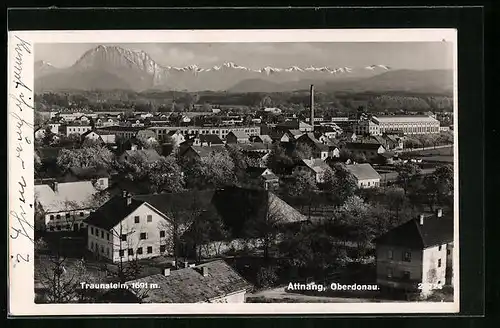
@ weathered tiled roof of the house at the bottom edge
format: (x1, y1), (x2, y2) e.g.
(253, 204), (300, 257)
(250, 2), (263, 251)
(123, 260), (253, 303)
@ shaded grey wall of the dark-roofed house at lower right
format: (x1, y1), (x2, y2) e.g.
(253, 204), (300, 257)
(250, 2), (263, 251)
(377, 245), (423, 289)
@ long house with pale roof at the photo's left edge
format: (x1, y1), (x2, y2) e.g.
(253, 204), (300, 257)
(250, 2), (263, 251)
(35, 181), (100, 232)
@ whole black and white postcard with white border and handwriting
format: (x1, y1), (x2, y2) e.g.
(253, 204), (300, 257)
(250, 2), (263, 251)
(8, 29), (460, 315)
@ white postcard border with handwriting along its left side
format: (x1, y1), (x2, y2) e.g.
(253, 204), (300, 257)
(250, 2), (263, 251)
(7, 29), (460, 316)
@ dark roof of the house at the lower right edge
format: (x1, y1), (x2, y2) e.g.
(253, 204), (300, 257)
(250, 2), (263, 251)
(375, 215), (453, 249)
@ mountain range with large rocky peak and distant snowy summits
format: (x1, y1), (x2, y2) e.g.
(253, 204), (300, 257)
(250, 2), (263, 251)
(35, 45), (453, 93)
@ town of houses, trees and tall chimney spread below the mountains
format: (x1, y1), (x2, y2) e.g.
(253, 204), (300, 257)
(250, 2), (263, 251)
(34, 85), (453, 303)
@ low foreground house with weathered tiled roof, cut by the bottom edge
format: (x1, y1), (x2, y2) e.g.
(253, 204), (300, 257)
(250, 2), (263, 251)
(103, 260), (253, 304)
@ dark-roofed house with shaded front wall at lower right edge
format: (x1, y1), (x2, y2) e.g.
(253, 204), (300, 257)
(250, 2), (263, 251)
(375, 209), (453, 295)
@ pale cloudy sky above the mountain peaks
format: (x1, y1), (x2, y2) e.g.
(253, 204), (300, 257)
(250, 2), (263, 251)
(34, 42), (453, 69)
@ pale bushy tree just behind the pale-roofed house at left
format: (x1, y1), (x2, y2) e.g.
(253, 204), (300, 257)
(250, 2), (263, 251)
(57, 146), (113, 171)
